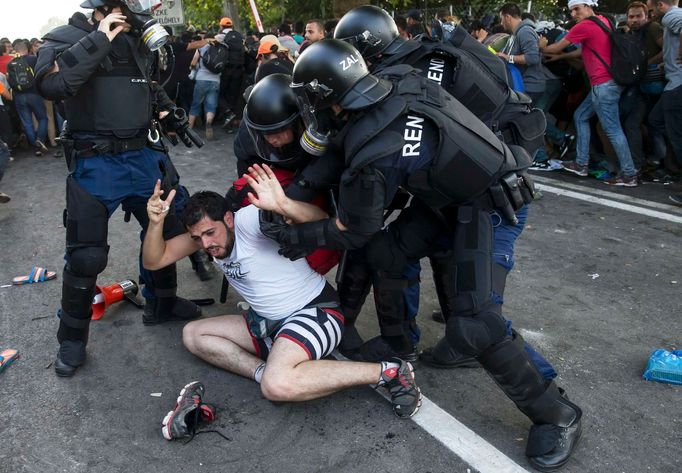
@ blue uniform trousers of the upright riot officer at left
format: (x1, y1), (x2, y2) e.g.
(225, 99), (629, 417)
(72, 148), (187, 299)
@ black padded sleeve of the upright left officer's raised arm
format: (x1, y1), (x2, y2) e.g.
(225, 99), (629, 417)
(36, 31), (115, 100)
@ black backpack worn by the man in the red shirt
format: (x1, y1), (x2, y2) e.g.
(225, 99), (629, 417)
(587, 16), (648, 86)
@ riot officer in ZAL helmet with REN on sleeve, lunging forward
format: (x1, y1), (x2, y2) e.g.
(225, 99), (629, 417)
(255, 40), (582, 470)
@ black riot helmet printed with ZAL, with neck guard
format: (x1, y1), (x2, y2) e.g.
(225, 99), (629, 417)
(291, 39), (392, 112)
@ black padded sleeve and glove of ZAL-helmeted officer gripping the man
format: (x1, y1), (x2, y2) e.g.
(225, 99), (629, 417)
(261, 167), (386, 257)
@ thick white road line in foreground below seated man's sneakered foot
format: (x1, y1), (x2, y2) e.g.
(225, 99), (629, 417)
(332, 350), (529, 473)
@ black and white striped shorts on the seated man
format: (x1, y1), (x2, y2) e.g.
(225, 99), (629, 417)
(245, 307), (344, 360)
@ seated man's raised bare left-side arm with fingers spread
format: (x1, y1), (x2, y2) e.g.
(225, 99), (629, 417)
(142, 180), (200, 271)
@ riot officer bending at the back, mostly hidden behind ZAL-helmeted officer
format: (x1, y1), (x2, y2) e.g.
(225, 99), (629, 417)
(334, 5), (556, 370)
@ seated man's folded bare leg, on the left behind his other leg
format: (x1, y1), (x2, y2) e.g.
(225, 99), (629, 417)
(182, 315), (263, 379)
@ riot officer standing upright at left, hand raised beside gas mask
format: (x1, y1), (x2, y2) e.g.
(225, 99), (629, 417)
(36, 0), (206, 376)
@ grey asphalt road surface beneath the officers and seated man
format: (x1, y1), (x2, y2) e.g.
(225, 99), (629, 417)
(0, 133), (682, 473)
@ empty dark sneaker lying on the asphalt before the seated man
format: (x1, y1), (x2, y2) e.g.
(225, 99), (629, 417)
(161, 381), (215, 440)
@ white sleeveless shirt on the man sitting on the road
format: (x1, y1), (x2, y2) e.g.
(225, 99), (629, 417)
(213, 205), (326, 320)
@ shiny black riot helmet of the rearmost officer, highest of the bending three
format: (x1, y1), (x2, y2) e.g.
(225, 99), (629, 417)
(334, 5), (405, 59)
